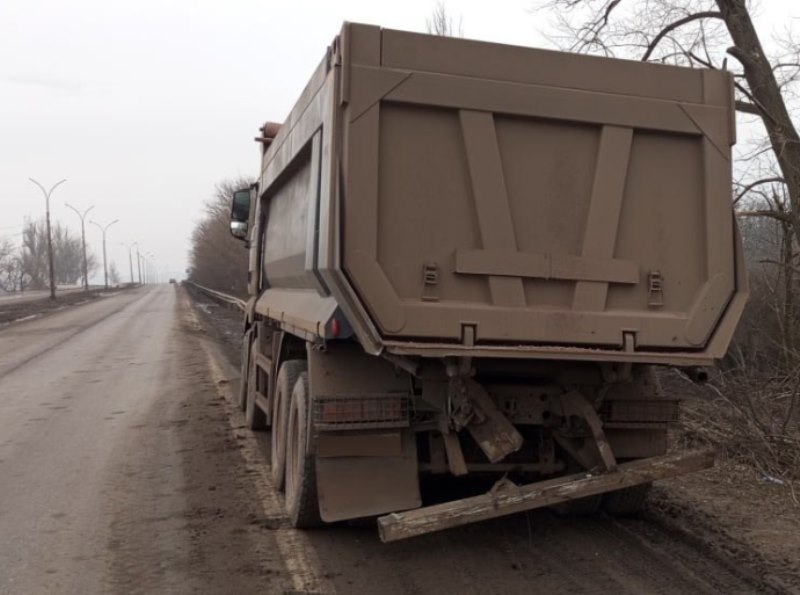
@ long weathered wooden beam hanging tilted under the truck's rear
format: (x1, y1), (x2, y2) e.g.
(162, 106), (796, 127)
(378, 450), (714, 542)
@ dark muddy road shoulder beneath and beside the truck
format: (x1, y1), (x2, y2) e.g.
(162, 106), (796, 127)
(186, 286), (800, 594)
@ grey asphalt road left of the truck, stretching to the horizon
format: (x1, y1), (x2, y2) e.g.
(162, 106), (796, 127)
(0, 285), (286, 595)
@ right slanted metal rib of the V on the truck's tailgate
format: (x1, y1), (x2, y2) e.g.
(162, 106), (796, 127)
(572, 126), (633, 312)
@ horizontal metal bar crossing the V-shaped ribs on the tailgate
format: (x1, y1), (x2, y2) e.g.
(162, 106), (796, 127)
(456, 250), (639, 284)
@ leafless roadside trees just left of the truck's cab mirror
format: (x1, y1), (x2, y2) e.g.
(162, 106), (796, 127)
(189, 177), (252, 296)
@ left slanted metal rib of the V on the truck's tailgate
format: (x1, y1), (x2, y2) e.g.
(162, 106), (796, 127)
(459, 110), (525, 308)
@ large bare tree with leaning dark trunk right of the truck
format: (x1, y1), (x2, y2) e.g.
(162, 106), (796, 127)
(545, 0), (800, 358)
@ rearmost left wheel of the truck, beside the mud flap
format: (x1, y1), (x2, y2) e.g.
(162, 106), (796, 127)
(286, 372), (322, 529)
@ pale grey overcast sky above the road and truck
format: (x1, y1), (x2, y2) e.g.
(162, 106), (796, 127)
(0, 0), (800, 280)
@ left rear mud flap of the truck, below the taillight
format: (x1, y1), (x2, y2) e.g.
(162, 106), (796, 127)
(316, 432), (422, 522)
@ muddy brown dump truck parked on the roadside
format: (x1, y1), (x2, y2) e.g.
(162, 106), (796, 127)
(231, 23), (747, 541)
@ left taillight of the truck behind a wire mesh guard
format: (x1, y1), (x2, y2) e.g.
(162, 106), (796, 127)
(314, 396), (409, 430)
